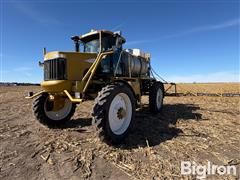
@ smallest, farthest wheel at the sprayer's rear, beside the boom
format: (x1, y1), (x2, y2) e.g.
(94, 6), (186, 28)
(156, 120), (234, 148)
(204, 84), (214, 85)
(149, 82), (164, 113)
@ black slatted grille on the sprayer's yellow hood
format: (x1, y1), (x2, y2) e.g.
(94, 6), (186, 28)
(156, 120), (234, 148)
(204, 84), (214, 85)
(44, 58), (67, 81)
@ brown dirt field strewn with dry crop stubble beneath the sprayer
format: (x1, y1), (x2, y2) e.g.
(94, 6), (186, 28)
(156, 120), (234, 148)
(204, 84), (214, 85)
(0, 84), (240, 180)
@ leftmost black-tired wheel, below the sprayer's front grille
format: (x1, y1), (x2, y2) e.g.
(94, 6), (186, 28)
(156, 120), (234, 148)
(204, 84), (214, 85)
(32, 93), (76, 127)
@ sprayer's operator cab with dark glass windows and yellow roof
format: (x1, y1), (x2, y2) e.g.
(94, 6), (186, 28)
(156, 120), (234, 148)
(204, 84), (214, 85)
(72, 30), (126, 79)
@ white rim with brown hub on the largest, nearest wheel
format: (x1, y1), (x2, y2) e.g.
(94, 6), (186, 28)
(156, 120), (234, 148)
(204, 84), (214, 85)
(108, 93), (132, 135)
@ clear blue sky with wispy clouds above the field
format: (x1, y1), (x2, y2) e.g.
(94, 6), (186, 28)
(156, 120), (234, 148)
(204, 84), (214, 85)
(0, 0), (240, 82)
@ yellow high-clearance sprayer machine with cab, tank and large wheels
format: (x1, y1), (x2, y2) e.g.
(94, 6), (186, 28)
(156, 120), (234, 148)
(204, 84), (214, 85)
(26, 30), (164, 144)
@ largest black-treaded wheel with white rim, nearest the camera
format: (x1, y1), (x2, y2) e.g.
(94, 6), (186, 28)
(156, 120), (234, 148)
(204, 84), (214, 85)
(92, 83), (135, 144)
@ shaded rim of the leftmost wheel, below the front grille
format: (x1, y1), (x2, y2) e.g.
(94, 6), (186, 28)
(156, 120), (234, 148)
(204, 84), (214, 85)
(44, 98), (72, 121)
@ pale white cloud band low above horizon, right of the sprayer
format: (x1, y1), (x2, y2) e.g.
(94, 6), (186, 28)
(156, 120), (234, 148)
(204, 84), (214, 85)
(166, 72), (240, 83)
